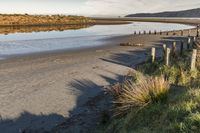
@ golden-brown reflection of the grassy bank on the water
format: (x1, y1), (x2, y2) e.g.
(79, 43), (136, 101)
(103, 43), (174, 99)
(0, 25), (90, 35)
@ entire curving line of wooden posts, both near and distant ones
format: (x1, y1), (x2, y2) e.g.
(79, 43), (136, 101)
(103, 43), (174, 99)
(134, 25), (200, 71)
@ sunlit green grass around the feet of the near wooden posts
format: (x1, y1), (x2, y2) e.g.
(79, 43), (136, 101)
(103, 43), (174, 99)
(138, 55), (198, 86)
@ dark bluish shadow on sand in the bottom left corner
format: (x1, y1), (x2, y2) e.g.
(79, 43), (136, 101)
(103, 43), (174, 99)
(0, 112), (65, 133)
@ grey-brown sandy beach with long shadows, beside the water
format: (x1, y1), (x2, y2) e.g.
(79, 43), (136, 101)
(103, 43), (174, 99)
(0, 23), (198, 133)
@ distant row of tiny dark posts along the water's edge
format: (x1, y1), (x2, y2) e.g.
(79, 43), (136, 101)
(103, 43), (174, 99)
(134, 30), (191, 36)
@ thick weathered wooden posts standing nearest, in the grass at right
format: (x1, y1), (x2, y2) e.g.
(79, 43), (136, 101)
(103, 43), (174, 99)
(151, 37), (197, 71)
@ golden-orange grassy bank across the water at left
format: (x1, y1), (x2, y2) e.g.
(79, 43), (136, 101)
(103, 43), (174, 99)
(0, 14), (95, 26)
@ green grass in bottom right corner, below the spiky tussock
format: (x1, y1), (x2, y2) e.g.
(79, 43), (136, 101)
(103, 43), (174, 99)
(101, 87), (200, 133)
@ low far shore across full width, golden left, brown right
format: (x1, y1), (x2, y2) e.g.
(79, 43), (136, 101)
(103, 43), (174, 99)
(0, 14), (200, 27)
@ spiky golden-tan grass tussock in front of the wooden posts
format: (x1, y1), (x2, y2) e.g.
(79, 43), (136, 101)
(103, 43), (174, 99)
(109, 76), (170, 115)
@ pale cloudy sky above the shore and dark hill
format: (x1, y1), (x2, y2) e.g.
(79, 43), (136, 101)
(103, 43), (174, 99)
(0, 0), (200, 16)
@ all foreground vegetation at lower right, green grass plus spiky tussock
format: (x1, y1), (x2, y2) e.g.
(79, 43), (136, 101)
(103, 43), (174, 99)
(98, 52), (200, 133)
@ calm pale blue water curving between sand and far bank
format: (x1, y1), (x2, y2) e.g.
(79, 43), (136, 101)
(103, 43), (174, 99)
(0, 22), (194, 58)
